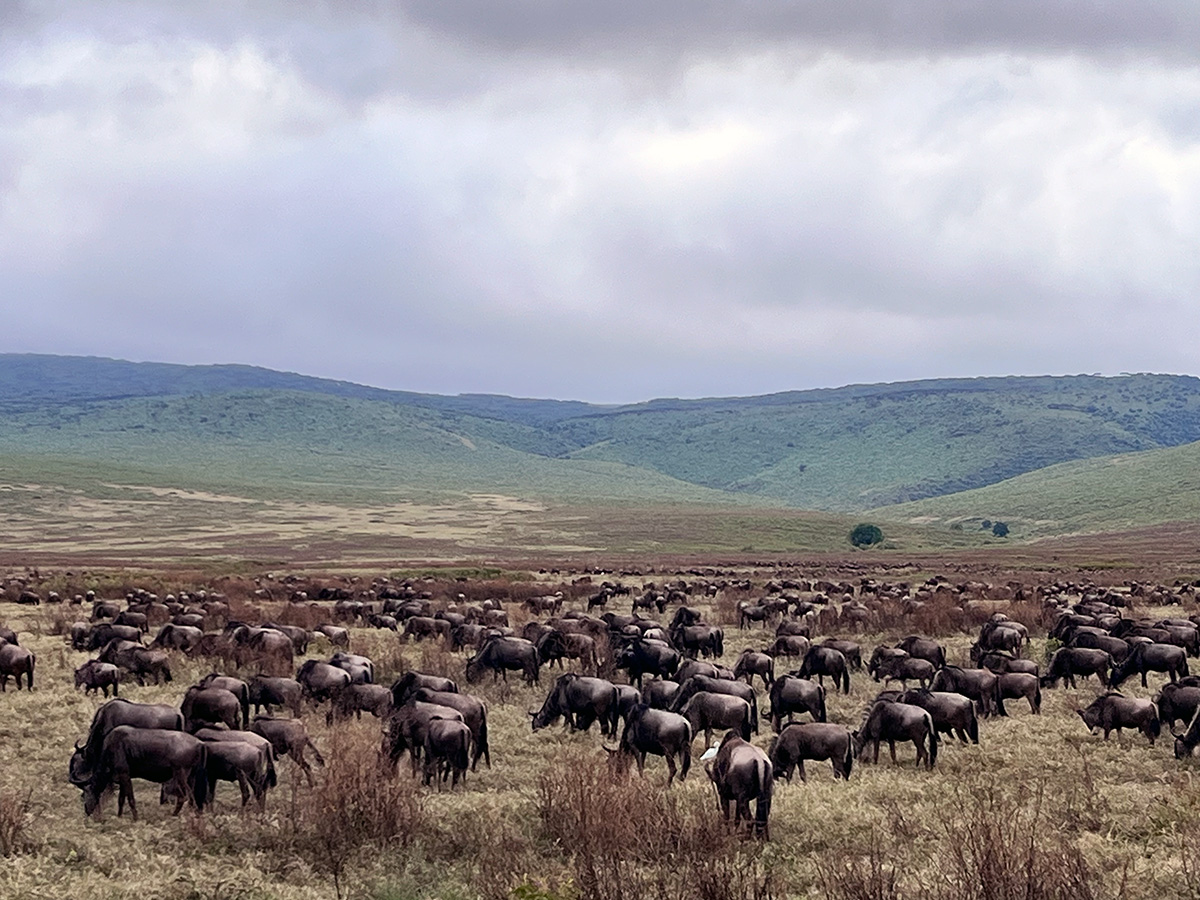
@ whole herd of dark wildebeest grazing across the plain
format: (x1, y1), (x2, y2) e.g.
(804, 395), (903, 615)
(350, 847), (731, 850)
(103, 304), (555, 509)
(7, 577), (1200, 836)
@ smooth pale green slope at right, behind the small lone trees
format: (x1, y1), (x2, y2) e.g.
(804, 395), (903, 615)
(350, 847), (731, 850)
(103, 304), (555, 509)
(874, 443), (1200, 539)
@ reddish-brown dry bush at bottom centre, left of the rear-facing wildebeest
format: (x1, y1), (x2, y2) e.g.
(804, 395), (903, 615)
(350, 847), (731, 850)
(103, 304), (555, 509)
(538, 751), (776, 900)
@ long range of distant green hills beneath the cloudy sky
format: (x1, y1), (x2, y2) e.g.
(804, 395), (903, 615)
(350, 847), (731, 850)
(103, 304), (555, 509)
(0, 355), (1200, 512)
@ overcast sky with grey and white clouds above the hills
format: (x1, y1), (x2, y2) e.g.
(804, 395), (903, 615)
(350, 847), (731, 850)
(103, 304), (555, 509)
(0, 0), (1200, 401)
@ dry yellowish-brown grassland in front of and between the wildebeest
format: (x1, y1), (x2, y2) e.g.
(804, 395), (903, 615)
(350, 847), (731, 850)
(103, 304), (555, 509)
(0, 571), (1200, 900)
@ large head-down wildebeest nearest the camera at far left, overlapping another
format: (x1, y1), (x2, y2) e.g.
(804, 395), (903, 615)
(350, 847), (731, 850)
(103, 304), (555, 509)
(72, 724), (209, 821)
